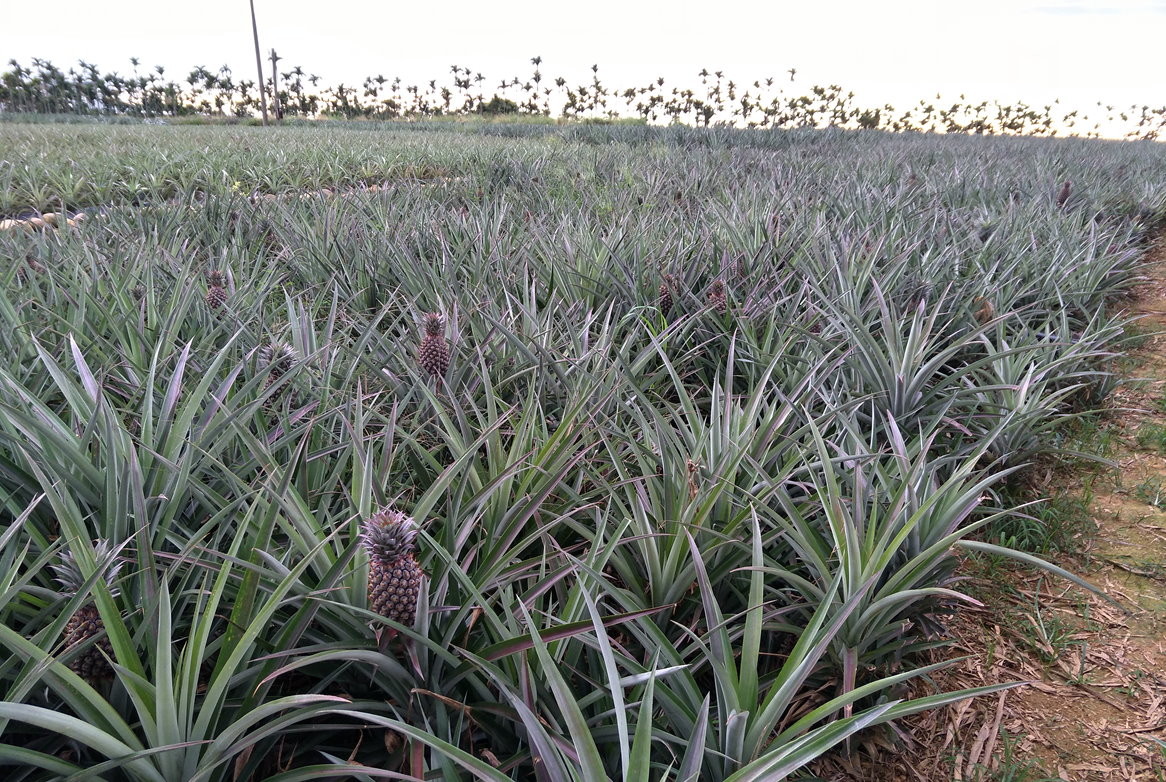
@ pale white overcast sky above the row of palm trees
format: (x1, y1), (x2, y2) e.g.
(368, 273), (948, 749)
(0, 0), (1166, 119)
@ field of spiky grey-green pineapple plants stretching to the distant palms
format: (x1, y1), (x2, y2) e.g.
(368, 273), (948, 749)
(0, 122), (1166, 782)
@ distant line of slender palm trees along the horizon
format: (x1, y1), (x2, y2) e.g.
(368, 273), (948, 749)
(0, 52), (1166, 140)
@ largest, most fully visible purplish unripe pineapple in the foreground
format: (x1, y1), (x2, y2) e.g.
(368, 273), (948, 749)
(360, 508), (421, 627)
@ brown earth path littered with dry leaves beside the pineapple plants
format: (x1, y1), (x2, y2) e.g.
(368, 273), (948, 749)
(816, 238), (1166, 782)
